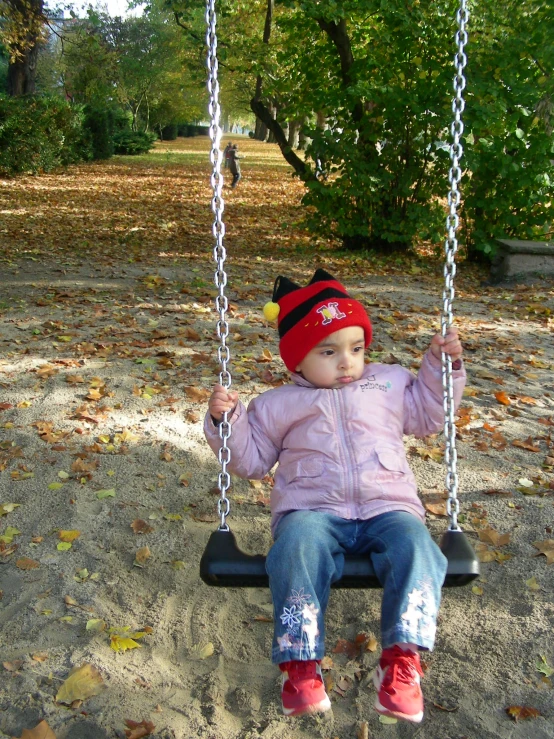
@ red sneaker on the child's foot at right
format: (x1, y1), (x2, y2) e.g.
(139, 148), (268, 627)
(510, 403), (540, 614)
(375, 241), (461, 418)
(373, 645), (423, 724)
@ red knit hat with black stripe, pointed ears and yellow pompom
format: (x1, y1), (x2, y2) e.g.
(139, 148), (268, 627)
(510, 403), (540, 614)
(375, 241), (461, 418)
(264, 269), (372, 372)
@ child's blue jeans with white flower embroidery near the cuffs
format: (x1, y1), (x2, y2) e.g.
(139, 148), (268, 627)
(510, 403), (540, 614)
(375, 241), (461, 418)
(266, 511), (447, 663)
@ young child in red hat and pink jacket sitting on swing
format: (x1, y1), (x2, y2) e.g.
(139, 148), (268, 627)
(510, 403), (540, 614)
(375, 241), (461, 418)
(204, 269), (465, 723)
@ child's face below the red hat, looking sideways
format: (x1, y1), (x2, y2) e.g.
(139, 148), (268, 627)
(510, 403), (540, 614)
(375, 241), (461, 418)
(296, 326), (365, 388)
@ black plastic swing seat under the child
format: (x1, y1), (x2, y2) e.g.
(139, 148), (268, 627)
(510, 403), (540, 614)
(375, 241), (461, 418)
(200, 529), (480, 588)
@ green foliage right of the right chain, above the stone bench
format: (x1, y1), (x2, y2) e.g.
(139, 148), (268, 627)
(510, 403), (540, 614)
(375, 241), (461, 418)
(462, 0), (554, 257)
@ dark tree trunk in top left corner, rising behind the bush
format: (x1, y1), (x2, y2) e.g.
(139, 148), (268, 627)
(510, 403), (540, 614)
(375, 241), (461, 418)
(5, 0), (45, 97)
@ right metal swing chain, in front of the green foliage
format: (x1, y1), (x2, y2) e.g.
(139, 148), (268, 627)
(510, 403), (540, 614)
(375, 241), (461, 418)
(441, 0), (469, 531)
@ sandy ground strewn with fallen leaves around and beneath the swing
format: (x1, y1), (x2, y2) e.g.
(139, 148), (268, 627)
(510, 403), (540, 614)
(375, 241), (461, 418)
(0, 254), (554, 739)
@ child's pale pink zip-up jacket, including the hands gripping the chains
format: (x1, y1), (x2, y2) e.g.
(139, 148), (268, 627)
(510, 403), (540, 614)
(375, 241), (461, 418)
(204, 351), (465, 531)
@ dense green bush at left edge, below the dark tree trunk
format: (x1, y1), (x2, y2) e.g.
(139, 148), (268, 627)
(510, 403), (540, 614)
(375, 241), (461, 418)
(0, 96), (91, 176)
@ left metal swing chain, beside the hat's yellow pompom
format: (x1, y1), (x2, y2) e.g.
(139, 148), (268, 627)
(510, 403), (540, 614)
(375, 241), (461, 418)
(206, 0), (231, 531)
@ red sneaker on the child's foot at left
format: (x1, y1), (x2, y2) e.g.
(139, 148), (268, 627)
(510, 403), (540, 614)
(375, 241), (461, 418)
(279, 660), (331, 716)
